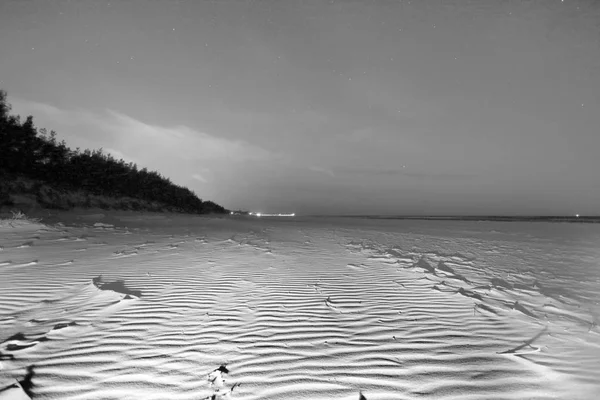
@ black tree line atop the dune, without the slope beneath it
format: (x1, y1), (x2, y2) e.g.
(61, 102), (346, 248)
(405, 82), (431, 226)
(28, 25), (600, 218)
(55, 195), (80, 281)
(0, 90), (228, 214)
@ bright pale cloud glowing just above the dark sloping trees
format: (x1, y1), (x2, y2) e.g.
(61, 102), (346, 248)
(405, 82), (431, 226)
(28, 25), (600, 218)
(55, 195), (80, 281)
(11, 99), (285, 200)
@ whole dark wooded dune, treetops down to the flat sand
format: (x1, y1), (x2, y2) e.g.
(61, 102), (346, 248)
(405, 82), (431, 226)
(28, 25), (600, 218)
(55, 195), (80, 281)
(0, 90), (228, 214)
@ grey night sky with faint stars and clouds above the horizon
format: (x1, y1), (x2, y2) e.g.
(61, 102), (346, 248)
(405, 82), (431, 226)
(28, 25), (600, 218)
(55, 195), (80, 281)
(0, 0), (600, 215)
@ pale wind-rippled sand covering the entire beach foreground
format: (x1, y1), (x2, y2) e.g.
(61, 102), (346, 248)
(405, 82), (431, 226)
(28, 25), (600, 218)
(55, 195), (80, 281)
(0, 213), (600, 400)
